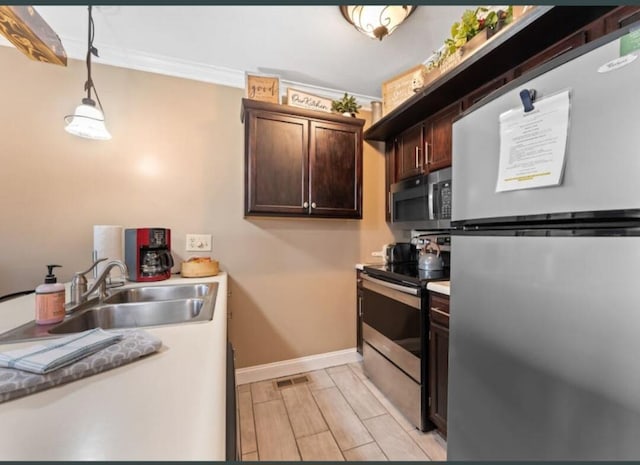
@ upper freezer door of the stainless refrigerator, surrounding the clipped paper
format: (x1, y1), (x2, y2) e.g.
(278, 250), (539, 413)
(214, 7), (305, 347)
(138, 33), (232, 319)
(452, 35), (640, 221)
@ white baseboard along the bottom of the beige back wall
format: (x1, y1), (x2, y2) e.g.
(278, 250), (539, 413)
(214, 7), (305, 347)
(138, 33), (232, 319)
(236, 347), (362, 384)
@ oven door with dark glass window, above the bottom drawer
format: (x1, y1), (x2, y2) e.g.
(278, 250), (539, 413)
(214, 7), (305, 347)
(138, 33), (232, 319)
(362, 276), (424, 383)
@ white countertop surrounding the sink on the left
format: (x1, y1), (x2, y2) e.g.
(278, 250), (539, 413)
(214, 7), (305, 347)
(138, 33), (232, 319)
(0, 273), (227, 461)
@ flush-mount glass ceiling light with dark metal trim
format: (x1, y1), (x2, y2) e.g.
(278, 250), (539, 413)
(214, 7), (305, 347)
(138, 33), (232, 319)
(340, 5), (417, 40)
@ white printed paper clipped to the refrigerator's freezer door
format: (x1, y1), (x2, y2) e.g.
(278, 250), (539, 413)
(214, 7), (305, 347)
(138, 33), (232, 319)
(496, 90), (569, 192)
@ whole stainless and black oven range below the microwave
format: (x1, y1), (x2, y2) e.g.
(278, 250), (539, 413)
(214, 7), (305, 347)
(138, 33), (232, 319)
(358, 236), (449, 431)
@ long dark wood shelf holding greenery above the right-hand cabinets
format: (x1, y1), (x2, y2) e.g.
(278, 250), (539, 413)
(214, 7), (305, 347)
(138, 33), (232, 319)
(364, 5), (615, 141)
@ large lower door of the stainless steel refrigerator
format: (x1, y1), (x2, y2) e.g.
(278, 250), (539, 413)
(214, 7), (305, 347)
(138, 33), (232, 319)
(447, 236), (640, 461)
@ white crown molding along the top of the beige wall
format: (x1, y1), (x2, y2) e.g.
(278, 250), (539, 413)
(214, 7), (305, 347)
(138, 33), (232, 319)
(0, 37), (381, 111)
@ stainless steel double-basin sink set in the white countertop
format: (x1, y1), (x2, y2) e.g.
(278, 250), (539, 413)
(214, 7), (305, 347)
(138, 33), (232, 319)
(0, 283), (218, 344)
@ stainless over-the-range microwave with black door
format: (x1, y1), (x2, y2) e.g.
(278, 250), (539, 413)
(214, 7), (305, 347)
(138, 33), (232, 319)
(391, 168), (451, 230)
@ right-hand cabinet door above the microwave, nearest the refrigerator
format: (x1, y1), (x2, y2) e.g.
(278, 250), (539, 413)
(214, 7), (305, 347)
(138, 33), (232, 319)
(425, 102), (460, 171)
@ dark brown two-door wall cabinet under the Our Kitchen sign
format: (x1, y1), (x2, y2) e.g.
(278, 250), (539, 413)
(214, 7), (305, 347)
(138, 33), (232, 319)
(242, 99), (364, 219)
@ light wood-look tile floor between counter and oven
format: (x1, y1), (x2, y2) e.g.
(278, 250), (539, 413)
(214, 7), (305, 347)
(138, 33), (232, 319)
(238, 363), (447, 461)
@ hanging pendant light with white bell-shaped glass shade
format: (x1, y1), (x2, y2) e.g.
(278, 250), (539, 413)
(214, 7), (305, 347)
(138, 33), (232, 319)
(64, 5), (111, 140)
